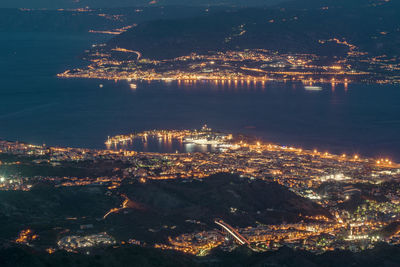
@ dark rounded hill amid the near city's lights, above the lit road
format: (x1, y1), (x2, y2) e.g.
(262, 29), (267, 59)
(118, 174), (329, 226)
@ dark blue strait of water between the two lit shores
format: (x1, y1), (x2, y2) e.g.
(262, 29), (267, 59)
(0, 33), (400, 161)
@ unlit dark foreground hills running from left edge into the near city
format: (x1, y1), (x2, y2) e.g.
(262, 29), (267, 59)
(0, 174), (330, 248)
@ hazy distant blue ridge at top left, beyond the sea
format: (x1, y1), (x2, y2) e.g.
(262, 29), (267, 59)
(0, 6), (222, 32)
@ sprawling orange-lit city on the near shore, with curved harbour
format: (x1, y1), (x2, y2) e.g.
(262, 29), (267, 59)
(0, 126), (400, 256)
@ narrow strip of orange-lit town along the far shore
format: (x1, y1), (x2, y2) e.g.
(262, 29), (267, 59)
(58, 44), (400, 87)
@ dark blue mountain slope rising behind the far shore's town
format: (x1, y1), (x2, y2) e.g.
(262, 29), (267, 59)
(108, 0), (400, 59)
